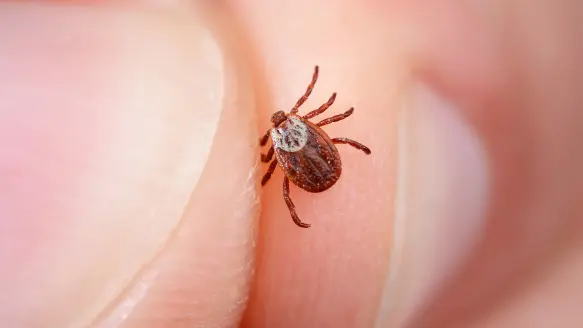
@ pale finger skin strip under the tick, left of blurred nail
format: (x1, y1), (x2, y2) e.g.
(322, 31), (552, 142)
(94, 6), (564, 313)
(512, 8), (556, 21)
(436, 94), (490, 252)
(229, 1), (402, 328)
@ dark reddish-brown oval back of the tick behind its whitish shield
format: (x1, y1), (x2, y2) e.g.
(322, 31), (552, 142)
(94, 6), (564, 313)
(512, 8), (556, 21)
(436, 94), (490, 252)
(274, 115), (342, 193)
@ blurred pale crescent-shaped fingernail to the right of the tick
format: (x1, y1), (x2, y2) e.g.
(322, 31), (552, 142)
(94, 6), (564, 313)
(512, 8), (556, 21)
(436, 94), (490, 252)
(377, 84), (487, 327)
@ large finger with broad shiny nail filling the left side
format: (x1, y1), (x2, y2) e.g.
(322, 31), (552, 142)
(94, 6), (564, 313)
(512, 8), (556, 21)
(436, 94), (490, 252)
(0, 3), (256, 327)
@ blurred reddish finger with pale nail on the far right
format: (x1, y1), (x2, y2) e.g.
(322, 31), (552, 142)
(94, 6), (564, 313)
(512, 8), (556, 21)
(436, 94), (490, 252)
(379, 2), (583, 327)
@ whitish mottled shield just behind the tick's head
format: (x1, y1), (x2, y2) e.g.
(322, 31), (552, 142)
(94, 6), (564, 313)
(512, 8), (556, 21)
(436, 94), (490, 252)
(271, 116), (308, 153)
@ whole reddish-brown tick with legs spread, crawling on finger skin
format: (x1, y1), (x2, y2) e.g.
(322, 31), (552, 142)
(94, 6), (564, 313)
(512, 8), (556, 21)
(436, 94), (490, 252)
(259, 66), (370, 228)
